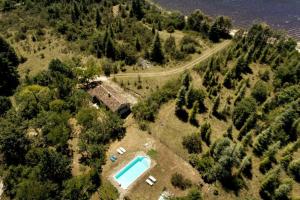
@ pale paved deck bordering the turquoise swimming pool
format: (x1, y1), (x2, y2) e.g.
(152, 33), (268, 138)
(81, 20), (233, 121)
(108, 151), (156, 199)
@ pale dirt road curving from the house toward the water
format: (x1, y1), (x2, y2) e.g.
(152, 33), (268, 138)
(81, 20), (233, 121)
(114, 40), (231, 78)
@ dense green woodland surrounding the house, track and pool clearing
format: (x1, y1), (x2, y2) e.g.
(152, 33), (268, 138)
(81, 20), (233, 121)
(0, 0), (300, 200)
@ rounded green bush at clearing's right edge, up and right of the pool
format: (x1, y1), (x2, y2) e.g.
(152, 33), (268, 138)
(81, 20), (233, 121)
(182, 133), (202, 153)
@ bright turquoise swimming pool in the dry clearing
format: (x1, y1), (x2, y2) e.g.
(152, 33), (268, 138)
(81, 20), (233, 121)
(114, 156), (151, 189)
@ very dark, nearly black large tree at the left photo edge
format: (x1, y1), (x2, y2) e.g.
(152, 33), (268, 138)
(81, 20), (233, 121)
(0, 37), (19, 96)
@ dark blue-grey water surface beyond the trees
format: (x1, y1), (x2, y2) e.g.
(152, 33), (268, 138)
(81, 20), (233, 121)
(154, 0), (300, 39)
